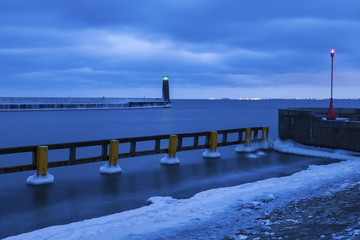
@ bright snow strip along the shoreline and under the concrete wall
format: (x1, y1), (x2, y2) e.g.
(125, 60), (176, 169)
(8, 140), (360, 240)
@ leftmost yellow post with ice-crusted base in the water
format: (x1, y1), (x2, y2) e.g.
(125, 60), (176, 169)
(26, 146), (54, 185)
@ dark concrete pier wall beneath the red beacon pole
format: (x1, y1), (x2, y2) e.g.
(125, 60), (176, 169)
(278, 108), (360, 151)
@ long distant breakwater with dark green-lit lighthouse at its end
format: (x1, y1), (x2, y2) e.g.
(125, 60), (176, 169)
(0, 76), (171, 111)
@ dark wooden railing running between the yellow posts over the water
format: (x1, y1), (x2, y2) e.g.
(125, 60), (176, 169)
(0, 127), (268, 174)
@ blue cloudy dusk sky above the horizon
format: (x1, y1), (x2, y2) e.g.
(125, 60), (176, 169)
(0, 0), (360, 98)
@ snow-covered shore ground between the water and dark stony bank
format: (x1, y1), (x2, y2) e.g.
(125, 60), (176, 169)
(7, 140), (360, 240)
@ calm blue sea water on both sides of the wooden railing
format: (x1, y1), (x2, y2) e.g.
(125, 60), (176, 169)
(0, 100), (360, 238)
